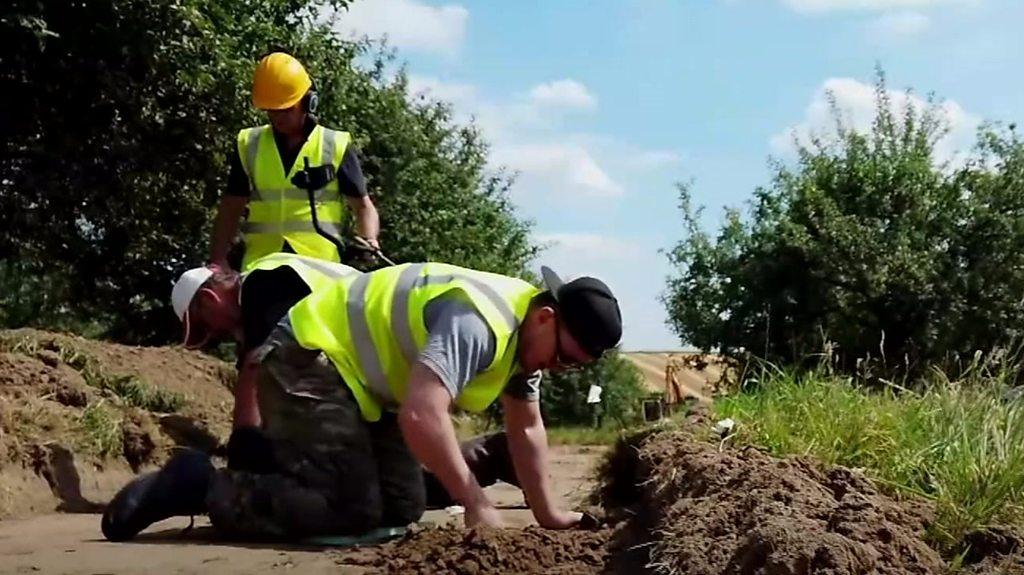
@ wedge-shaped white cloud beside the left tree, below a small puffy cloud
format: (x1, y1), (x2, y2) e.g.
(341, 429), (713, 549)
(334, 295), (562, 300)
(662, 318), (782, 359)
(492, 143), (624, 197)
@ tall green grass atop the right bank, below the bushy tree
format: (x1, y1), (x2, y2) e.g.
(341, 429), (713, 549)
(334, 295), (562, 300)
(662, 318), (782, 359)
(716, 364), (1024, 554)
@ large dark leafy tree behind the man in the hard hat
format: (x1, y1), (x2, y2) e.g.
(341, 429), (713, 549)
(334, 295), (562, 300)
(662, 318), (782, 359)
(0, 0), (537, 343)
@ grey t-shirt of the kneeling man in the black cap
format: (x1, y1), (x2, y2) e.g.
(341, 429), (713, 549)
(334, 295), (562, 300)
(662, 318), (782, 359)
(420, 297), (542, 401)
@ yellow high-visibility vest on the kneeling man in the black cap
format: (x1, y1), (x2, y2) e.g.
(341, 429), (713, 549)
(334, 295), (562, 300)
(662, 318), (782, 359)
(289, 263), (540, 422)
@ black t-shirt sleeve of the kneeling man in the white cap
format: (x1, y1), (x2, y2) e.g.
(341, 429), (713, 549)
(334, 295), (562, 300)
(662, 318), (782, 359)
(239, 267), (309, 364)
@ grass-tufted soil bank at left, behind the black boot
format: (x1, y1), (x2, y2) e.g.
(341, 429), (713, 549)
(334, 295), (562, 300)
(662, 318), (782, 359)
(0, 329), (233, 519)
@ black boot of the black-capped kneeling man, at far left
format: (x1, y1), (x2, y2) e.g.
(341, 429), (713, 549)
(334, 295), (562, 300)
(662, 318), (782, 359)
(99, 449), (214, 541)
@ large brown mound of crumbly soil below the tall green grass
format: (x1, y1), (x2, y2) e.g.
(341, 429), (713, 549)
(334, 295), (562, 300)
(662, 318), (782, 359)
(603, 432), (945, 575)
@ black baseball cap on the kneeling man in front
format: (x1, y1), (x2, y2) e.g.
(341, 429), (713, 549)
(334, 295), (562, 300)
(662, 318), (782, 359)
(541, 266), (623, 358)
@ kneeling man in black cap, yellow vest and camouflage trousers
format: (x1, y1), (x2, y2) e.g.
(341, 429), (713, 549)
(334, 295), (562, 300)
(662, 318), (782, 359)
(102, 263), (622, 539)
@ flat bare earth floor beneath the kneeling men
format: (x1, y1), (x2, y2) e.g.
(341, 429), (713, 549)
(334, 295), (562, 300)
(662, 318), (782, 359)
(0, 446), (601, 575)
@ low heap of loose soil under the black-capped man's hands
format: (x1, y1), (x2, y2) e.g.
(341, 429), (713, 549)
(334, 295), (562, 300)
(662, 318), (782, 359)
(356, 527), (615, 575)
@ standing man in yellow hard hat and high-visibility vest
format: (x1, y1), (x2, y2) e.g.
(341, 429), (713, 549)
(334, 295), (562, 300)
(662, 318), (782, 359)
(210, 52), (380, 271)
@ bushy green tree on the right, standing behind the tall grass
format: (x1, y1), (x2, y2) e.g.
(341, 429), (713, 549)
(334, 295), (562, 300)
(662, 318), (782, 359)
(664, 73), (1024, 372)
